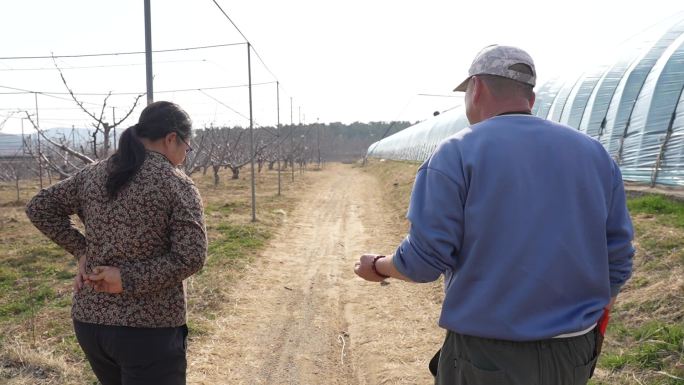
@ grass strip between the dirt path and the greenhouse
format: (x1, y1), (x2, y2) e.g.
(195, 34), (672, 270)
(364, 160), (684, 385)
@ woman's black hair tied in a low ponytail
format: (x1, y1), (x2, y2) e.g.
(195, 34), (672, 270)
(105, 101), (192, 198)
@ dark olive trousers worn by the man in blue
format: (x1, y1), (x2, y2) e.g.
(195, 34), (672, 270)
(435, 329), (597, 385)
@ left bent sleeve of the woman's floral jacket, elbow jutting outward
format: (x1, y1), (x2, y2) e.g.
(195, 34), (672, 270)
(26, 168), (88, 259)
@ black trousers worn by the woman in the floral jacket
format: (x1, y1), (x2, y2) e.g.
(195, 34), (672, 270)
(74, 321), (188, 385)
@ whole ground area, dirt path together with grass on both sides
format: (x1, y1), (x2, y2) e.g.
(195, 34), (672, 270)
(0, 161), (684, 385)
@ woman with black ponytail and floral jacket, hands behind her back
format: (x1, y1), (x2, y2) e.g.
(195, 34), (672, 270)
(26, 102), (207, 385)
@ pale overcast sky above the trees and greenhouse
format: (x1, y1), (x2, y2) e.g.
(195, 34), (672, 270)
(0, 0), (684, 132)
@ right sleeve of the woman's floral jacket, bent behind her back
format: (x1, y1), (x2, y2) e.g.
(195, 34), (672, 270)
(120, 183), (207, 294)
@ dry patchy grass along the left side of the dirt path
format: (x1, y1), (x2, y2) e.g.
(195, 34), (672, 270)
(0, 169), (313, 384)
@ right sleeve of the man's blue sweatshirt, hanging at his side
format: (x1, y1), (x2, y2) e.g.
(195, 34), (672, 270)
(606, 162), (634, 297)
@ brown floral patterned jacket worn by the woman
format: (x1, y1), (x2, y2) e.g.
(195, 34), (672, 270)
(26, 151), (207, 327)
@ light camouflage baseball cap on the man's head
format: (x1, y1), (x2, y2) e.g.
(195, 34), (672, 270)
(454, 44), (537, 92)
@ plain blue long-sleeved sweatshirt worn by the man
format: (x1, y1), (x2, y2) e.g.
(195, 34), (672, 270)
(394, 115), (634, 341)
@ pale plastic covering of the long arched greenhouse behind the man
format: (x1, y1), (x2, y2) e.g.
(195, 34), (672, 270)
(368, 14), (684, 186)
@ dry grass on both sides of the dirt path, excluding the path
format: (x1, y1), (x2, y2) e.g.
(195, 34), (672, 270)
(5, 161), (684, 385)
